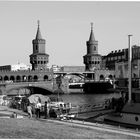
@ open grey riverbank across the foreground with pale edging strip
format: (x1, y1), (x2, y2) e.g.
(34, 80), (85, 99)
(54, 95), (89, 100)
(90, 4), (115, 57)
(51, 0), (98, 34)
(0, 107), (140, 139)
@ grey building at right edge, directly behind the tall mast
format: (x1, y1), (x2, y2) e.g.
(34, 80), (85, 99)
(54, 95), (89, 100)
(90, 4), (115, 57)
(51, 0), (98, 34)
(115, 45), (140, 88)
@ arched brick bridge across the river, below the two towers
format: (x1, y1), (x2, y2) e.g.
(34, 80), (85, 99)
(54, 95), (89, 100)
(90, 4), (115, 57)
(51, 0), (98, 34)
(0, 70), (114, 95)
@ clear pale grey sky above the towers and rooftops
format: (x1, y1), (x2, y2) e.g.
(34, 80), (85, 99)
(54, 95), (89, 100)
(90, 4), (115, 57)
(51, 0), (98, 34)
(0, 1), (140, 66)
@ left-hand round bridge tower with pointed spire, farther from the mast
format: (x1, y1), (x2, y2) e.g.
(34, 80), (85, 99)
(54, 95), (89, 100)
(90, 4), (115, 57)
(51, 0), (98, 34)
(30, 20), (49, 70)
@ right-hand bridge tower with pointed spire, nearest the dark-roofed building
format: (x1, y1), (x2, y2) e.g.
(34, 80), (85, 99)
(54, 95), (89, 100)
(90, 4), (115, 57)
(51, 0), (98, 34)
(83, 23), (101, 71)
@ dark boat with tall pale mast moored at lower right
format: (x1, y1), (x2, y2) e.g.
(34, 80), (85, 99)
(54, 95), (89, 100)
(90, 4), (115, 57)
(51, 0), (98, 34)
(104, 35), (140, 128)
